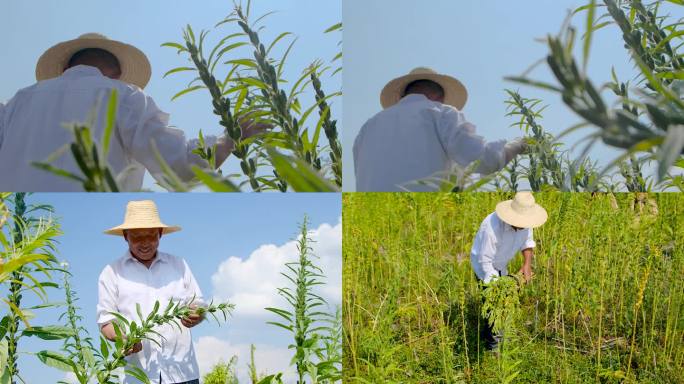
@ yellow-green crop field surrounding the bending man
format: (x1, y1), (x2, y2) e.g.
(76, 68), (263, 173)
(343, 193), (684, 383)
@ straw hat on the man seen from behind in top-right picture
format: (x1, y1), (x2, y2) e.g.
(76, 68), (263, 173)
(380, 67), (468, 110)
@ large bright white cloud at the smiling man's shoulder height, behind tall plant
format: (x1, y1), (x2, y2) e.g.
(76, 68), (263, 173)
(211, 218), (342, 317)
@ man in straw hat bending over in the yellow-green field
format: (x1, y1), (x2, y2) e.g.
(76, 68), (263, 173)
(470, 192), (548, 350)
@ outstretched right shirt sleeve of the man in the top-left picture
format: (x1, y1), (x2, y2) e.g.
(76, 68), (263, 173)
(117, 89), (217, 181)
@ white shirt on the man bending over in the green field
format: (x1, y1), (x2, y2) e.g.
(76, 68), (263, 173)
(470, 212), (537, 283)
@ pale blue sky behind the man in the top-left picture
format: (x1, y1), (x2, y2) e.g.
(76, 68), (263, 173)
(0, 0), (342, 188)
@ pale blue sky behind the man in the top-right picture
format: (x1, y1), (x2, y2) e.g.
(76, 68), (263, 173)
(342, 0), (672, 191)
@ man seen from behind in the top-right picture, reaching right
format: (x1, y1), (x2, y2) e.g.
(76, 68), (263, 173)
(354, 68), (525, 191)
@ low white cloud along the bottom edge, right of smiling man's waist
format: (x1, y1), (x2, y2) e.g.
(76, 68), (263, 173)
(195, 336), (295, 383)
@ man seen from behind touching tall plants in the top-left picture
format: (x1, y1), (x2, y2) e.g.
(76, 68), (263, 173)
(0, 33), (265, 191)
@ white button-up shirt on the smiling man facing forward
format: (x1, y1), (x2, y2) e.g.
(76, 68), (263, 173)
(97, 252), (203, 384)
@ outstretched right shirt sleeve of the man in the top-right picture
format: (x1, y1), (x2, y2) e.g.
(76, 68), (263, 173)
(438, 106), (506, 174)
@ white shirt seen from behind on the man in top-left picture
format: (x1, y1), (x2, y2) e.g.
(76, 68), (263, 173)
(0, 65), (216, 192)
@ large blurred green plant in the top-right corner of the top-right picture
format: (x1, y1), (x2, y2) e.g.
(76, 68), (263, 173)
(509, 0), (684, 181)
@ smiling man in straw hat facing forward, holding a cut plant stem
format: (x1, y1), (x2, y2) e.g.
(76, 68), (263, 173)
(97, 200), (204, 384)
